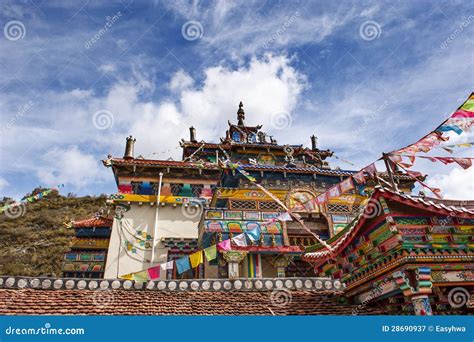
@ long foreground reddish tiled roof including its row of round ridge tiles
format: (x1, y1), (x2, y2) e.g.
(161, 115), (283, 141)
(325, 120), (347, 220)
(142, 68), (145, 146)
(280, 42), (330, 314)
(0, 277), (384, 315)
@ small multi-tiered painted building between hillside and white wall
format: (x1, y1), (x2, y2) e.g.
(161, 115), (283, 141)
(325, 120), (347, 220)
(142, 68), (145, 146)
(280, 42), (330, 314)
(63, 217), (112, 278)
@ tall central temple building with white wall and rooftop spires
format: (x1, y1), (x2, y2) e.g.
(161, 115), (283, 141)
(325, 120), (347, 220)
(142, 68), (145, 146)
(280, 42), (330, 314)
(103, 104), (413, 279)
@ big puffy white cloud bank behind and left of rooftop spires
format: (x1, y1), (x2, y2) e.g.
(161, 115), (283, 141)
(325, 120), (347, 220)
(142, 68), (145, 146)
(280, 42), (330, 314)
(0, 55), (306, 194)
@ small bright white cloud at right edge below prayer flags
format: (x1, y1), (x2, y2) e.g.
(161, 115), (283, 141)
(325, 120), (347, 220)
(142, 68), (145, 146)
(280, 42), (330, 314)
(427, 167), (474, 200)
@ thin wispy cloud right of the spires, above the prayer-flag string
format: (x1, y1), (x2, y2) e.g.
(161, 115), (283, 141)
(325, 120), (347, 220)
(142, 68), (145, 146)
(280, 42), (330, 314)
(282, 33), (472, 170)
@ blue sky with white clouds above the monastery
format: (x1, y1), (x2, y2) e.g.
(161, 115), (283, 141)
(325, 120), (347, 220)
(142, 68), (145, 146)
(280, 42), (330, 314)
(0, 1), (474, 198)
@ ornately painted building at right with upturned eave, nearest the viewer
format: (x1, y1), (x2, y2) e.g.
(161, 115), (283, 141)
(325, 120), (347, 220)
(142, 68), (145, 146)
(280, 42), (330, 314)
(303, 188), (474, 315)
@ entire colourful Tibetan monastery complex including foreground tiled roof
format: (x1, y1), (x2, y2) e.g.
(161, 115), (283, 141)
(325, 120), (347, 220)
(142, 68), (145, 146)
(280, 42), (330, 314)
(0, 99), (474, 315)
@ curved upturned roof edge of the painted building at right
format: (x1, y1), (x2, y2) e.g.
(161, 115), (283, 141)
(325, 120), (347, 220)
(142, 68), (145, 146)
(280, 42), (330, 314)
(303, 187), (474, 262)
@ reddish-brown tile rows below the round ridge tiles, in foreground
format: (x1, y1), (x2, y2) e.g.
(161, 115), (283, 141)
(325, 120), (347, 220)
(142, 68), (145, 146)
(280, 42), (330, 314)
(0, 289), (383, 315)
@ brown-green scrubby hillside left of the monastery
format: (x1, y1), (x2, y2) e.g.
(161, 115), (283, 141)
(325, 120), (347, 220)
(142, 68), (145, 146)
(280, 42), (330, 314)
(0, 189), (107, 276)
